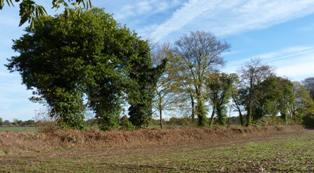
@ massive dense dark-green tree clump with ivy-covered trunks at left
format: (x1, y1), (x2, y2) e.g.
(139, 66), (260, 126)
(8, 9), (150, 130)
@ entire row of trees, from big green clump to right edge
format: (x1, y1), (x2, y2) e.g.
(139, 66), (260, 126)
(7, 8), (314, 130)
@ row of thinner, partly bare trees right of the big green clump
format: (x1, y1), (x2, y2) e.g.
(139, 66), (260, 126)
(154, 39), (314, 127)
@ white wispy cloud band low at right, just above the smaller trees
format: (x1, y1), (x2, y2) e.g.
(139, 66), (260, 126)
(225, 46), (314, 80)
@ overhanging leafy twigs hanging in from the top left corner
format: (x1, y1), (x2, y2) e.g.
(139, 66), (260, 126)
(0, 0), (92, 28)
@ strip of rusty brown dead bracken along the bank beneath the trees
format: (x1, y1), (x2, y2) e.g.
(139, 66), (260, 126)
(0, 126), (303, 153)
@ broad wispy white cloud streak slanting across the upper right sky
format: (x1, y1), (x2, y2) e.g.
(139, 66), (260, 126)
(150, 0), (314, 41)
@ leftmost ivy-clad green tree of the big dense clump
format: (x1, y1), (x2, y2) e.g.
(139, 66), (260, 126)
(8, 9), (109, 129)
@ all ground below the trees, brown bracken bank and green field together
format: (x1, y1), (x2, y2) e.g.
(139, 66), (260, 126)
(0, 127), (314, 172)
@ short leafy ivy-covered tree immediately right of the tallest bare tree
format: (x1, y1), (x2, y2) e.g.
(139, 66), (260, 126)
(206, 72), (237, 126)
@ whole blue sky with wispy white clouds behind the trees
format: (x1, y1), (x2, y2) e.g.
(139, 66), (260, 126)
(0, 0), (314, 120)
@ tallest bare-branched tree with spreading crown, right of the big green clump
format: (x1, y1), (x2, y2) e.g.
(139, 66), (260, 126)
(174, 31), (229, 126)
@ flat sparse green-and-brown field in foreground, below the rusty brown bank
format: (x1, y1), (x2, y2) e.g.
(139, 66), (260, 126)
(0, 126), (314, 173)
